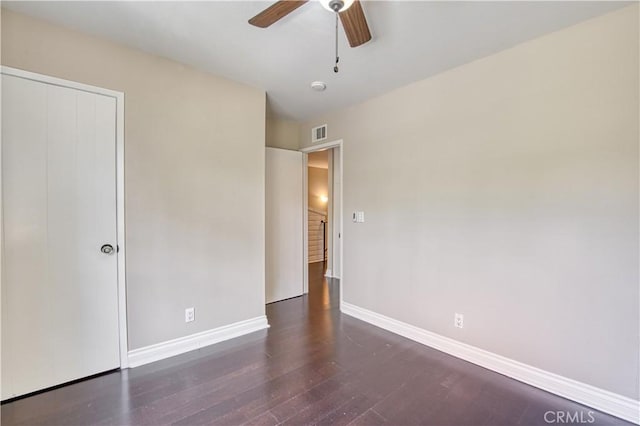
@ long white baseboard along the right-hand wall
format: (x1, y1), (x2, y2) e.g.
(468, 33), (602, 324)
(340, 302), (640, 424)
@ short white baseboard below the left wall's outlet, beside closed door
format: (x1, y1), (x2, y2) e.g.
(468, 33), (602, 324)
(128, 315), (269, 368)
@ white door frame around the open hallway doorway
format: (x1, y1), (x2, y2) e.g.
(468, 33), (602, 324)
(300, 139), (344, 302)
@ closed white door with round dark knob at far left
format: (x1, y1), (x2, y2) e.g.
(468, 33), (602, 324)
(2, 75), (120, 399)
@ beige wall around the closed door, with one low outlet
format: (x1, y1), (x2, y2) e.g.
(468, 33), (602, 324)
(2, 10), (265, 349)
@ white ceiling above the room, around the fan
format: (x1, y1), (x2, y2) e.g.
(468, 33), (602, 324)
(2, 0), (629, 120)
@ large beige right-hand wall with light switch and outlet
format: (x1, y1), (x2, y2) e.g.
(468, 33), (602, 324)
(300, 5), (640, 399)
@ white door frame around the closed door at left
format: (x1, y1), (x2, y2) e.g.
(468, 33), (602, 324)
(0, 65), (129, 369)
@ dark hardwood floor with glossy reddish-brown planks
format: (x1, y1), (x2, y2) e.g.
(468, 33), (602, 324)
(2, 263), (629, 425)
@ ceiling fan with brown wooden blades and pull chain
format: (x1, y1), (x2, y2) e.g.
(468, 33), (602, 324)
(249, 0), (371, 72)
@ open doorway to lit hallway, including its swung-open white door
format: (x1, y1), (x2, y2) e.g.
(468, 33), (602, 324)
(265, 141), (342, 304)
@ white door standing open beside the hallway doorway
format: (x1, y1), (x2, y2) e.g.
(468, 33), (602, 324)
(265, 148), (304, 303)
